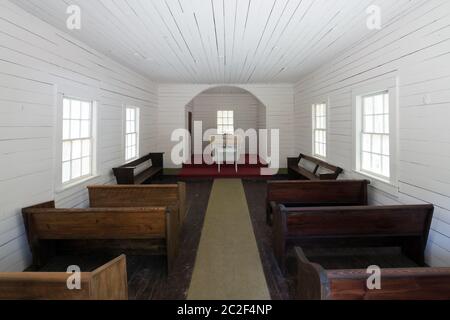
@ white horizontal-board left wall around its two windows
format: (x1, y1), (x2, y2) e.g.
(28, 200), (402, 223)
(0, 1), (157, 271)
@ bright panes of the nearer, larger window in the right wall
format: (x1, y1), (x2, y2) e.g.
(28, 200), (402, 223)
(360, 91), (391, 179)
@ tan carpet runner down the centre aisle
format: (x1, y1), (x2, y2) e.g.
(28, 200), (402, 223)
(188, 179), (270, 300)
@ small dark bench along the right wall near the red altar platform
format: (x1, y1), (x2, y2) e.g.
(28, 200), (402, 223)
(287, 154), (344, 180)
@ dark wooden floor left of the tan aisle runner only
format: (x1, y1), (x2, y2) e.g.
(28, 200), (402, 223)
(37, 177), (213, 300)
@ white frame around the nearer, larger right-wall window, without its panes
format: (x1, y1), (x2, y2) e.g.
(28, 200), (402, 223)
(352, 78), (399, 189)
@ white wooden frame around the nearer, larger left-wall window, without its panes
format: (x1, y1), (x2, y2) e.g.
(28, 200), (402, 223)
(54, 95), (98, 192)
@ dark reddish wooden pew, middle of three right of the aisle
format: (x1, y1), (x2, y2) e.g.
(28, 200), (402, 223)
(273, 205), (434, 271)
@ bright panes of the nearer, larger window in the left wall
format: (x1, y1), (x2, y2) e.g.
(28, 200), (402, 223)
(62, 98), (93, 184)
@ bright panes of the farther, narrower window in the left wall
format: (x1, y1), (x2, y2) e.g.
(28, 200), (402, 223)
(125, 107), (139, 161)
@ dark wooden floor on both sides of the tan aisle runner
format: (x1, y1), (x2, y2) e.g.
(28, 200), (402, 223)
(34, 177), (415, 300)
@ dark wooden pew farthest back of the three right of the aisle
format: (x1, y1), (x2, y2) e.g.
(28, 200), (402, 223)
(266, 180), (370, 225)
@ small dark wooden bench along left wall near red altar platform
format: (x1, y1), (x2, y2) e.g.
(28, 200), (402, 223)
(113, 153), (164, 184)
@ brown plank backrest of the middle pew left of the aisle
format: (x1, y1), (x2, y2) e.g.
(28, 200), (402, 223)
(23, 207), (169, 240)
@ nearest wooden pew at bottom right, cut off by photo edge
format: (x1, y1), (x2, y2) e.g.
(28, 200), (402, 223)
(294, 247), (450, 300)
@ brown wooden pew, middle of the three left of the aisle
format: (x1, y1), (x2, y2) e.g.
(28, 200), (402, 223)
(22, 202), (180, 271)
